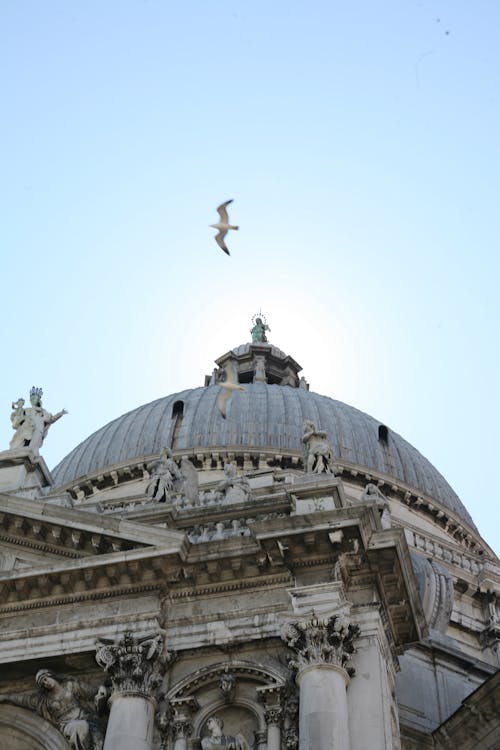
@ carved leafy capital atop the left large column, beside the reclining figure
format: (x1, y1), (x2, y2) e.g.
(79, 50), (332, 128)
(96, 631), (173, 698)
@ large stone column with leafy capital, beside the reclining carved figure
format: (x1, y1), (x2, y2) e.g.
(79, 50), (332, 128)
(96, 632), (171, 750)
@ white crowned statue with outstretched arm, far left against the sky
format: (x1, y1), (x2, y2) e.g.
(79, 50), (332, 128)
(10, 386), (68, 453)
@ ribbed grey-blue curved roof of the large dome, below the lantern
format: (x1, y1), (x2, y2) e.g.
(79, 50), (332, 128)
(53, 383), (475, 528)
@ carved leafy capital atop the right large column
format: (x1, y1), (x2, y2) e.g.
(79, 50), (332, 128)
(281, 614), (359, 677)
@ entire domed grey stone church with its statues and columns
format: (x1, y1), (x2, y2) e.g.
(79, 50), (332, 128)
(0, 318), (500, 750)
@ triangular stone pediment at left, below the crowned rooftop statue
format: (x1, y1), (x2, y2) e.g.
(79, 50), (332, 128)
(0, 495), (189, 614)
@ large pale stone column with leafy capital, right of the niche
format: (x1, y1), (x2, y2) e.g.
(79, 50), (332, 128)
(282, 614), (358, 750)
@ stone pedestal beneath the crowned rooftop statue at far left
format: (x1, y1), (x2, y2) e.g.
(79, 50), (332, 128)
(0, 448), (53, 494)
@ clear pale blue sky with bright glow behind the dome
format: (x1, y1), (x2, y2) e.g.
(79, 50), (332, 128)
(0, 0), (500, 552)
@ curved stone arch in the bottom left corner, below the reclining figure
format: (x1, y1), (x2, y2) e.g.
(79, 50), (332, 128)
(0, 704), (70, 750)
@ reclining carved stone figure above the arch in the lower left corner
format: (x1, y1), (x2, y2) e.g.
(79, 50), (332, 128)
(0, 669), (108, 750)
